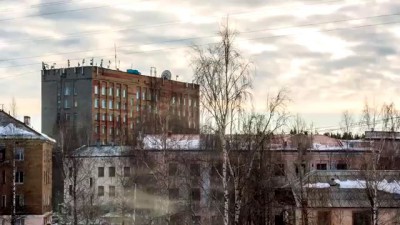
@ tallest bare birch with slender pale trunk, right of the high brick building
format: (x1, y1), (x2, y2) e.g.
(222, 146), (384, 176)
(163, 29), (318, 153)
(193, 22), (251, 225)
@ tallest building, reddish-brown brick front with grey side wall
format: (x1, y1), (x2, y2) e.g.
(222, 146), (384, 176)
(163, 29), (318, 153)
(42, 66), (199, 146)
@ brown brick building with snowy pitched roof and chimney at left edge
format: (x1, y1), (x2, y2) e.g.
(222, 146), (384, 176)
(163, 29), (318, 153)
(0, 110), (55, 225)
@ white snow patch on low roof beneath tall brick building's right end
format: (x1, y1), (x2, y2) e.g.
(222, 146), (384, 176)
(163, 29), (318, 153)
(143, 135), (200, 150)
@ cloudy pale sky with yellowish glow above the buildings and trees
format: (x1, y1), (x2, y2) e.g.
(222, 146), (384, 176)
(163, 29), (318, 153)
(0, 0), (400, 134)
